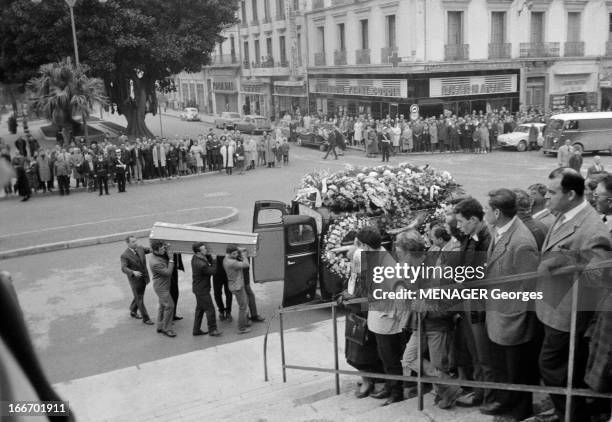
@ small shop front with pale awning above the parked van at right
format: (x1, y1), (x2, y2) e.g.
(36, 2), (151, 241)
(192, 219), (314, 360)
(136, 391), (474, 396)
(550, 73), (599, 111)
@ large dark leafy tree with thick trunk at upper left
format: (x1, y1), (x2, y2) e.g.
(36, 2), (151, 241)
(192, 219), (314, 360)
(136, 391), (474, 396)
(0, 0), (237, 137)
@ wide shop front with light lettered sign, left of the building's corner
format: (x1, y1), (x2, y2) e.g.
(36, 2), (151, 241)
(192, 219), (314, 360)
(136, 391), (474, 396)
(309, 78), (409, 119)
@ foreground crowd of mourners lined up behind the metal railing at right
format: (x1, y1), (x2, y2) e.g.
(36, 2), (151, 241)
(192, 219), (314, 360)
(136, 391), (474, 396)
(339, 160), (612, 422)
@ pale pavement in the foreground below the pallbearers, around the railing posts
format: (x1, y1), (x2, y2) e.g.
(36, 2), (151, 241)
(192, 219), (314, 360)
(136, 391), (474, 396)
(55, 318), (493, 422)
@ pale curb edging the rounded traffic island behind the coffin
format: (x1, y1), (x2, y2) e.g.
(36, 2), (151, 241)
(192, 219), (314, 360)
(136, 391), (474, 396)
(0, 207), (239, 260)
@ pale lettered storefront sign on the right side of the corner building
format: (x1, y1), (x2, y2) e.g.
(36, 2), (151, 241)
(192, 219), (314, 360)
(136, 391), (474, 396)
(429, 74), (518, 97)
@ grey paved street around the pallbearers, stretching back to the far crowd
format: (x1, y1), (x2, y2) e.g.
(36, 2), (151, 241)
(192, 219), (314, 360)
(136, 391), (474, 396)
(0, 136), (612, 382)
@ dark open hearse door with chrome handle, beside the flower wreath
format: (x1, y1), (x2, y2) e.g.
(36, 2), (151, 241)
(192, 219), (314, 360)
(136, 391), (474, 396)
(283, 215), (319, 307)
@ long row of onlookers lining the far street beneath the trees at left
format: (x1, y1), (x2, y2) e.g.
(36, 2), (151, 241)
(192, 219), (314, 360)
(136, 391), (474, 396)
(0, 129), (290, 201)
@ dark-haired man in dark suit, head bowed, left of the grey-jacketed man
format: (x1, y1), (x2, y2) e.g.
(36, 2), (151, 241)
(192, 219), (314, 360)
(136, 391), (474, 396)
(454, 198), (496, 412)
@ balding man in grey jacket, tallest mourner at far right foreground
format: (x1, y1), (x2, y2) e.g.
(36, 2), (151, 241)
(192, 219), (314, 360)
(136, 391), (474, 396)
(536, 168), (612, 422)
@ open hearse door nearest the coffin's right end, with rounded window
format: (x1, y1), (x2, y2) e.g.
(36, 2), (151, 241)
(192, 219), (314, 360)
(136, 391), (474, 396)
(253, 201), (288, 283)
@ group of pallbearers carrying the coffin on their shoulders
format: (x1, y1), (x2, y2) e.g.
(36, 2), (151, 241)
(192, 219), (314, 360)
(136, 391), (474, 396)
(120, 236), (265, 337)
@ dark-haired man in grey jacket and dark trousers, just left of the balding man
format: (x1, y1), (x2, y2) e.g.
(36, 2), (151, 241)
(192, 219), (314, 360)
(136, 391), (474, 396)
(481, 189), (539, 420)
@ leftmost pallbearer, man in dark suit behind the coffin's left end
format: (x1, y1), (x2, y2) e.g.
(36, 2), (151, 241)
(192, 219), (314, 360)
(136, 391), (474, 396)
(121, 236), (153, 325)
